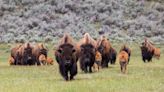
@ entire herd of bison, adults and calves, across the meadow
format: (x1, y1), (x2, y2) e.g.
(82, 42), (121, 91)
(9, 33), (160, 80)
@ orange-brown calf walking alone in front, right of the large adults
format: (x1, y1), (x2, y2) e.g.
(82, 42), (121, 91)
(118, 51), (129, 73)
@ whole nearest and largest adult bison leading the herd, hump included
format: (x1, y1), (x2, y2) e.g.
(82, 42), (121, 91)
(55, 34), (78, 81)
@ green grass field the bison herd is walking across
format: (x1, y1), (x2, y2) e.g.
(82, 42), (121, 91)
(0, 44), (164, 92)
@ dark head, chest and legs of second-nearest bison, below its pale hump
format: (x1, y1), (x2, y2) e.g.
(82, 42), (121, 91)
(80, 44), (95, 73)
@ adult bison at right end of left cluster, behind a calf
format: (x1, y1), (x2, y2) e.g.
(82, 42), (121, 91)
(32, 43), (48, 65)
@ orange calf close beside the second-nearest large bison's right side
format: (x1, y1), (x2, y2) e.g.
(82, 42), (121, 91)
(93, 51), (102, 71)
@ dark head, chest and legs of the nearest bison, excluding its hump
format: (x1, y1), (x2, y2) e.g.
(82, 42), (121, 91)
(55, 44), (77, 81)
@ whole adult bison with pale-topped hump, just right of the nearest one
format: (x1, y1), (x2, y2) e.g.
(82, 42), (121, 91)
(78, 33), (96, 73)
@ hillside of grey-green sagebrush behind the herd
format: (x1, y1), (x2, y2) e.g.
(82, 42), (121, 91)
(0, 0), (164, 43)
